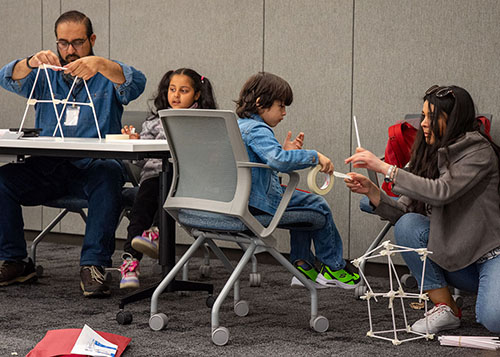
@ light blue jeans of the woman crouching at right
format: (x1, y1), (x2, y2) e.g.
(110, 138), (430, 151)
(394, 213), (500, 333)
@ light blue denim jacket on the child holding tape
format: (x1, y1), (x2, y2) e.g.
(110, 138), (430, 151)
(238, 114), (318, 214)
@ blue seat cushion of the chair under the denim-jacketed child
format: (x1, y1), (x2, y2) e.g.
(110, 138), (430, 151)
(179, 209), (326, 232)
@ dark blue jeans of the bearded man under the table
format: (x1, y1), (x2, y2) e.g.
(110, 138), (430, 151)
(0, 157), (125, 266)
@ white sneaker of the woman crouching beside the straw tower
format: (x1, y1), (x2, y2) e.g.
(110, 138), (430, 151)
(411, 304), (460, 334)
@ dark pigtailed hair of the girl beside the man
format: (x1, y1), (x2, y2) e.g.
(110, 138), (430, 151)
(151, 68), (217, 114)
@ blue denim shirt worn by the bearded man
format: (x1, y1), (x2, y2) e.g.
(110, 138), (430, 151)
(0, 60), (146, 138)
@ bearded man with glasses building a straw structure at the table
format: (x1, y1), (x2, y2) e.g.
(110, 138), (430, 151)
(0, 11), (146, 297)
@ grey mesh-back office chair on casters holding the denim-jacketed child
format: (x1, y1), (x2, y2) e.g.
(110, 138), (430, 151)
(149, 109), (328, 345)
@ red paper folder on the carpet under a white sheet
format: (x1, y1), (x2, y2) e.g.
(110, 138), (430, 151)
(26, 328), (132, 357)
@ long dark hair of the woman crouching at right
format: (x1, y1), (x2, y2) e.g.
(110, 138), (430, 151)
(409, 86), (500, 213)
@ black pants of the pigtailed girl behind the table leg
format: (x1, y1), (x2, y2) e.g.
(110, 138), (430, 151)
(123, 176), (160, 260)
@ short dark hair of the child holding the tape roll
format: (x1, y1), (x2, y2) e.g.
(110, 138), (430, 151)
(235, 72), (293, 118)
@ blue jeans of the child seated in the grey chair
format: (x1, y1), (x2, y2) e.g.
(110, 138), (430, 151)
(286, 191), (345, 270)
